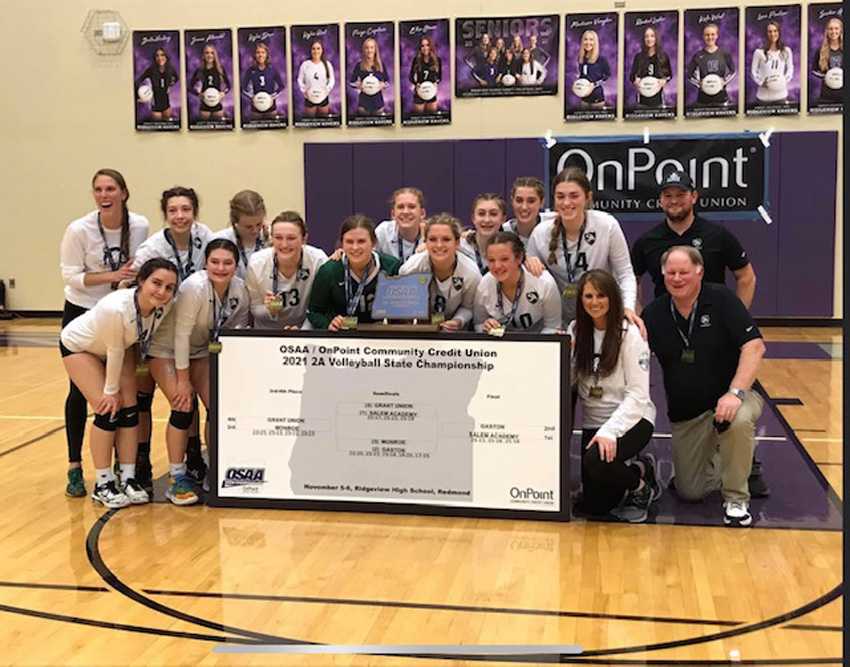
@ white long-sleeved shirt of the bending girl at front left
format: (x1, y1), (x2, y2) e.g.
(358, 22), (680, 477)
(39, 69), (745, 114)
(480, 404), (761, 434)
(59, 287), (171, 394)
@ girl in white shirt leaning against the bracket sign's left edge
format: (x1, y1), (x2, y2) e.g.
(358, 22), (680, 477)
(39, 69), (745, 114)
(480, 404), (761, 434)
(150, 239), (251, 505)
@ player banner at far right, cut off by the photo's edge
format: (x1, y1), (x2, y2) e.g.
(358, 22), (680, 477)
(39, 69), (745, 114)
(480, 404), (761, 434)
(808, 2), (844, 114)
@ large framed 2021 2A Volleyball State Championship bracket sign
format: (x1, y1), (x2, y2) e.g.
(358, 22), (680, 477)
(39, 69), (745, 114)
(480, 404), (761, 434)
(208, 331), (571, 521)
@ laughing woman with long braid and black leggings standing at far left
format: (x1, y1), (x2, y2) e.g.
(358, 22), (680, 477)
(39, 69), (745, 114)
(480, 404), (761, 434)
(60, 169), (149, 497)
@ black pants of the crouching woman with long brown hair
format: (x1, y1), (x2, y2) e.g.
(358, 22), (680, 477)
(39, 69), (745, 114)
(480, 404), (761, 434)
(579, 419), (653, 516)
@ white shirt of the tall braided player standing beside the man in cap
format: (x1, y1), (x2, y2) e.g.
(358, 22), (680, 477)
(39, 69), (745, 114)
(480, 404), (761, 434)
(526, 210), (637, 328)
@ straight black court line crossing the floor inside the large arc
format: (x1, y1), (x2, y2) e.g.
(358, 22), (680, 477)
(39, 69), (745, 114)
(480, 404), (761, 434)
(143, 588), (744, 627)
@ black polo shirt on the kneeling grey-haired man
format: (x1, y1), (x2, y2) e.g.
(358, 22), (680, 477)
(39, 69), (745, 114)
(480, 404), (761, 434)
(642, 283), (762, 422)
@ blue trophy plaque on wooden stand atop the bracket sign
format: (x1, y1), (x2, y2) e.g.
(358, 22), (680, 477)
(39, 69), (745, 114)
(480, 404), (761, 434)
(357, 273), (443, 331)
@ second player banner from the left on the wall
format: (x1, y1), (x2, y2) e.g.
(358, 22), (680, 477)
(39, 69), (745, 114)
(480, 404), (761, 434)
(183, 28), (233, 130)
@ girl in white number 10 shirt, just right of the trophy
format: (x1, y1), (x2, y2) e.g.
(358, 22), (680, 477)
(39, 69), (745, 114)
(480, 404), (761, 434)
(474, 232), (561, 335)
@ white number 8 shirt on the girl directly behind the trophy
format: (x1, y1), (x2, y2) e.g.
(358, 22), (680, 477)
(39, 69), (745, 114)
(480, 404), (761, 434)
(398, 252), (481, 329)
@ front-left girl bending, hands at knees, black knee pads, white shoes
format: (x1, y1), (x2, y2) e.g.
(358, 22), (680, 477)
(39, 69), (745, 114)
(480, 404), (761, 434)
(59, 259), (177, 508)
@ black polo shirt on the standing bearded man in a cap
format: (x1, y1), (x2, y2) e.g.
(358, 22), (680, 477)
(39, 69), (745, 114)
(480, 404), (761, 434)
(632, 216), (750, 296)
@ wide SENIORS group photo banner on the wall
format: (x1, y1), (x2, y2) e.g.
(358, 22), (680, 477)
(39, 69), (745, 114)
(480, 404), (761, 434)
(455, 14), (560, 97)
